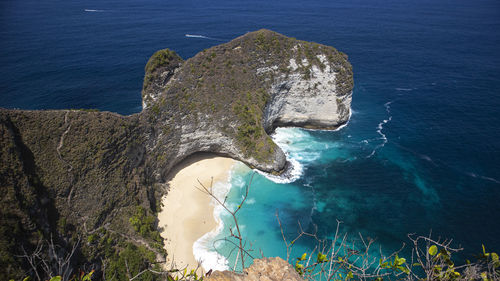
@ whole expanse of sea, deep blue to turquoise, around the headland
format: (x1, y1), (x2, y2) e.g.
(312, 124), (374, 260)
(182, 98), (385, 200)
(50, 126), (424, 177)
(0, 0), (500, 270)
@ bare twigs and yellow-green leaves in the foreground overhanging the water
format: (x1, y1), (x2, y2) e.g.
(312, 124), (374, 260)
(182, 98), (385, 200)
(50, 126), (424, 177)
(209, 176), (500, 281)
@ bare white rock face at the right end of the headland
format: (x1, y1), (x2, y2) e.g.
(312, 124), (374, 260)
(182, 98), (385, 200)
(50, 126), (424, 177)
(264, 55), (352, 131)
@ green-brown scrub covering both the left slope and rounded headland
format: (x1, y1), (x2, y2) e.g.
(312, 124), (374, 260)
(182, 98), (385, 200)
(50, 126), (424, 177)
(0, 30), (352, 280)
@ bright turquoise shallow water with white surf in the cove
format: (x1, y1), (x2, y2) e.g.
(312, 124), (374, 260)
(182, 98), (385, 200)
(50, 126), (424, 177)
(203, 128), (372, 269)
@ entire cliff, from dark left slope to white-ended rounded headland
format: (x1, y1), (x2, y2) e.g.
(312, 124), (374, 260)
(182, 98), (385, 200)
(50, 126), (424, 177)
(0, 30), (353, 279)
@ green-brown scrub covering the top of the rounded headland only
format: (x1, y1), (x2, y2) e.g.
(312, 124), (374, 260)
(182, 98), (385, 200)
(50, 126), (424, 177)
(144, 27), (352, 162)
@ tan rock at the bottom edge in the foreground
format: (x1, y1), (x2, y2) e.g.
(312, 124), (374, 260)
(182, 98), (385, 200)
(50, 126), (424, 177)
(206, 258), (304, 281)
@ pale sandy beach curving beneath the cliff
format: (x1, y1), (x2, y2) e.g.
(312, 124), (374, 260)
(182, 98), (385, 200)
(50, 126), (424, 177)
(158, 155), (236, 269)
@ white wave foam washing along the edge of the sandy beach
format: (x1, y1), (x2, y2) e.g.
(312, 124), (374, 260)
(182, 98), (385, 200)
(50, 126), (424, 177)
(193, 170), (232, 271)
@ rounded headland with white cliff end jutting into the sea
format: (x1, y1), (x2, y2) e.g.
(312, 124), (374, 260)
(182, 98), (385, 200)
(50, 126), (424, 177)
(143, 30), (353, 179)
